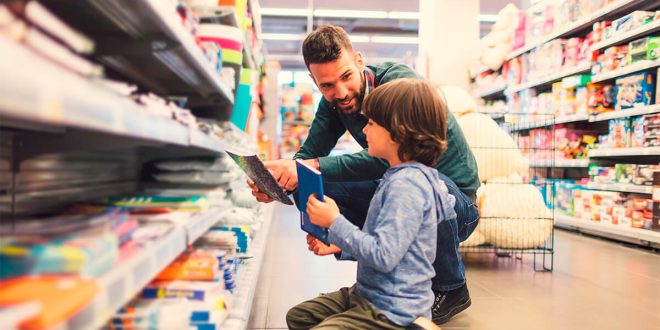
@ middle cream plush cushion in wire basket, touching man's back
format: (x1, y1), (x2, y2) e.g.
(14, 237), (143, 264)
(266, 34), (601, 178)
(457, 113), (529, 181)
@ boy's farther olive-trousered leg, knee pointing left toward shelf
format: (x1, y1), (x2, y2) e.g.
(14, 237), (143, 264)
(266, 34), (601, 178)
(286, 288), (350, 330)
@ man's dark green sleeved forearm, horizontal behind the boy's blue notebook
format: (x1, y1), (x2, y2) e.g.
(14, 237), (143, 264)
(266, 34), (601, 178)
(319, 149), (388, 182)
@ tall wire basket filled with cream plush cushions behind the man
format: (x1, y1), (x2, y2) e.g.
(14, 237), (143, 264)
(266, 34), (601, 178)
(459, 113), (555, 271)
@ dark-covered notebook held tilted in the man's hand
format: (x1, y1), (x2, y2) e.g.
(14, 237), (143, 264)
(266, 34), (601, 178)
(225, 149), (293, 205)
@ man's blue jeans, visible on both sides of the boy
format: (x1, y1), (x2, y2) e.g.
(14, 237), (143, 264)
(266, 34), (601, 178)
(323, 173), (479, 291)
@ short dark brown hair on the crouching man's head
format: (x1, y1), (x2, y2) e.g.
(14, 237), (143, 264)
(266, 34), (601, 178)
(303, 25), (353, 68)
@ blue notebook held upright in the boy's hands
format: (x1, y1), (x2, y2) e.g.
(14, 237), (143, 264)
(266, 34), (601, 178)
(296, 159), (330, 245)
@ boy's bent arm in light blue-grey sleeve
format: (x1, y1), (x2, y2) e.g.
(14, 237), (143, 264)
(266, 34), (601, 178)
(328, 179), (426, 272)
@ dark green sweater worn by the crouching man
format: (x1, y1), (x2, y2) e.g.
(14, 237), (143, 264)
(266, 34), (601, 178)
(294, 62), (479, 195)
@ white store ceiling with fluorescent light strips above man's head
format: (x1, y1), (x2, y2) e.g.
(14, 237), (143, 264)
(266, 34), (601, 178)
(259, 0), (528, 70)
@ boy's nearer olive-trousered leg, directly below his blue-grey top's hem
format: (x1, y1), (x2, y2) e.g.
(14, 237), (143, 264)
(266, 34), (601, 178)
(314, 287), (406, 330)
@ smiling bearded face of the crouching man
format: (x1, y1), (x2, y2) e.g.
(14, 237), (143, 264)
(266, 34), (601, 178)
(309, 50), (364, 114)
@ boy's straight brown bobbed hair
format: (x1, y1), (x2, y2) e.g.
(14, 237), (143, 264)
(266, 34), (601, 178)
(362, 78), (447, 166)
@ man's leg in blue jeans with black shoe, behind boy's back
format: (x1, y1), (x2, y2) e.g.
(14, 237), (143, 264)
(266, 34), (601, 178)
(432, 173), (479, 324)
